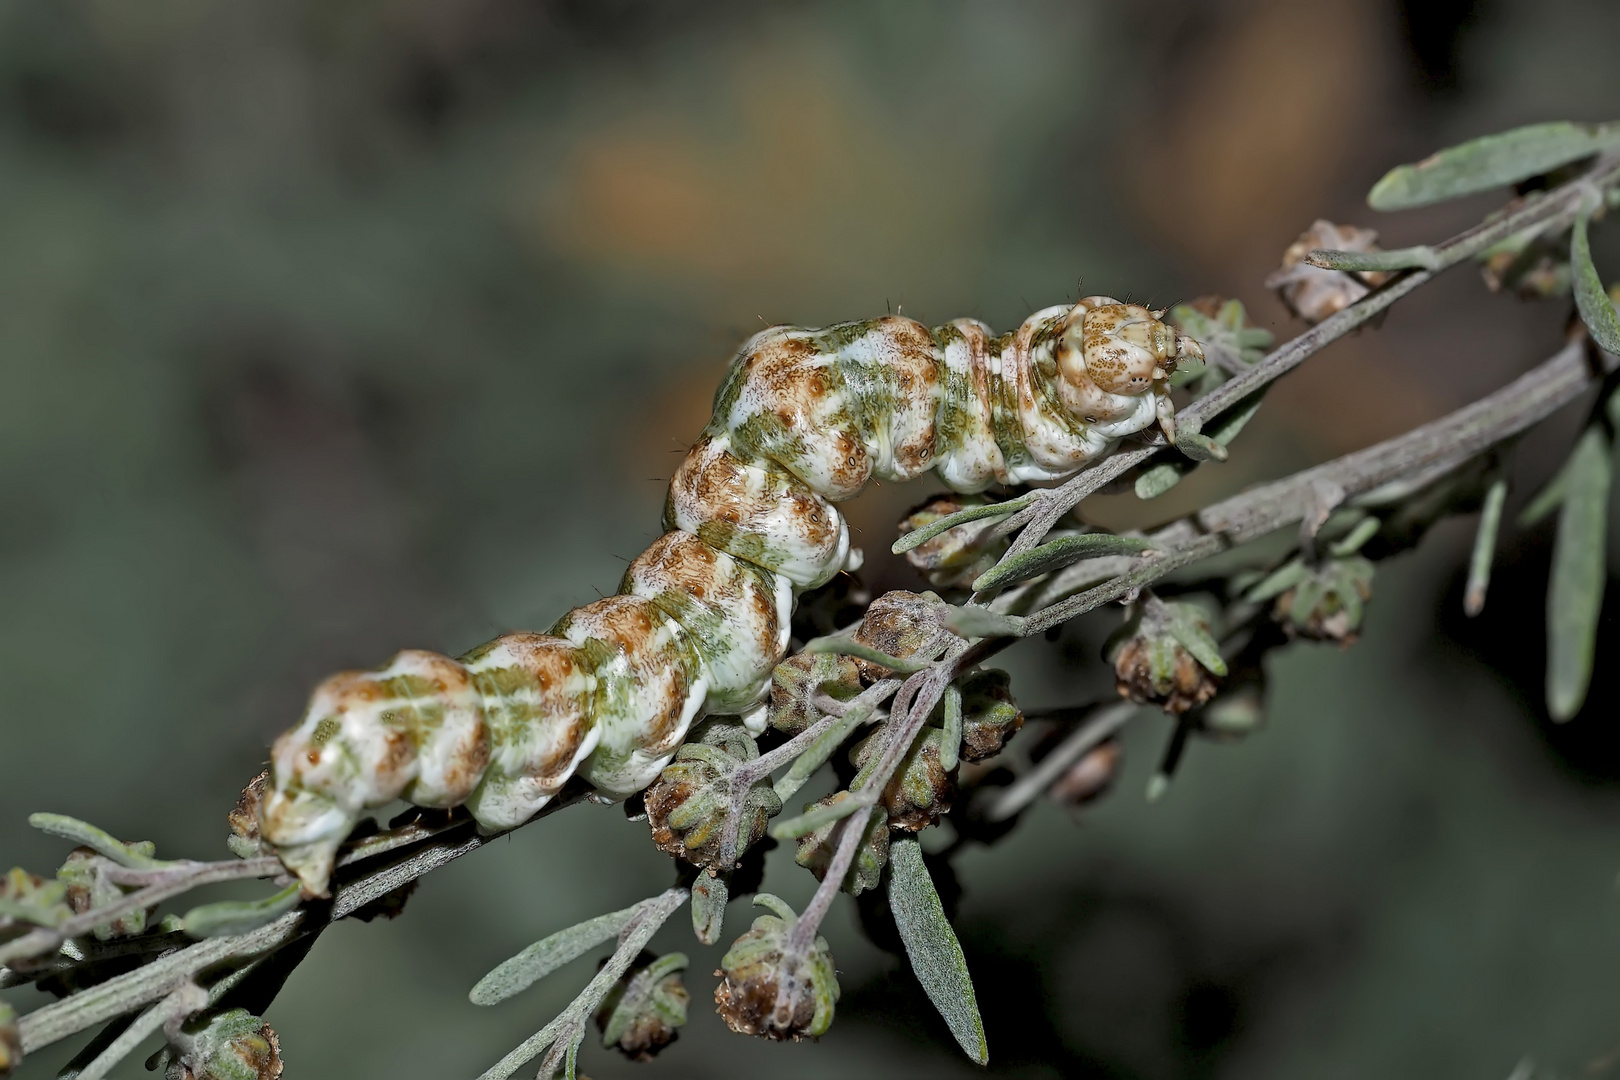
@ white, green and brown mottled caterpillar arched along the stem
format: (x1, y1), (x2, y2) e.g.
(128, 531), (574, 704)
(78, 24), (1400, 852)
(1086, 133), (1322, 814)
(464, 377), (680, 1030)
(258, 296), (1202, 895)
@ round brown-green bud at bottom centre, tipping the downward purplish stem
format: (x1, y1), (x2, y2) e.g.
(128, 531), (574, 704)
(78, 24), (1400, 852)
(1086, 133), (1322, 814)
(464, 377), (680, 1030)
(714, 892), (839, 1041)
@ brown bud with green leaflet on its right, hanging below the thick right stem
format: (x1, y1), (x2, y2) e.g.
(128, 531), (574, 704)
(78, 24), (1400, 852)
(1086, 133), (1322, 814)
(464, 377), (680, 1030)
(1110, 597), (1226, 714)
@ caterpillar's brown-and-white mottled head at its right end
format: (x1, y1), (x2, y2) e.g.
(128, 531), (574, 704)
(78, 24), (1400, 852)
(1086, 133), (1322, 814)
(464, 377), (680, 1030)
(1058, 296), (1204, 440)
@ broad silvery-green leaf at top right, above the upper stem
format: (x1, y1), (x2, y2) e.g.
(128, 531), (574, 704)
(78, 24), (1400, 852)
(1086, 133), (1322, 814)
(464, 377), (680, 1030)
(1367, 121), (1620, 210)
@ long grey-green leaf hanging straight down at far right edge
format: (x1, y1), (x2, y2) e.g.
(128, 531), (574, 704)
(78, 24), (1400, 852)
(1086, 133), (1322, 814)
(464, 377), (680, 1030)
(1547, 426), (1610, 721)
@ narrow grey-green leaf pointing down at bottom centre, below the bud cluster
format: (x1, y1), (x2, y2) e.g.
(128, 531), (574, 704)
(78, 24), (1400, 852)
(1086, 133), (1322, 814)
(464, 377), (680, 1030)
(889, 837), (990, 1065)
